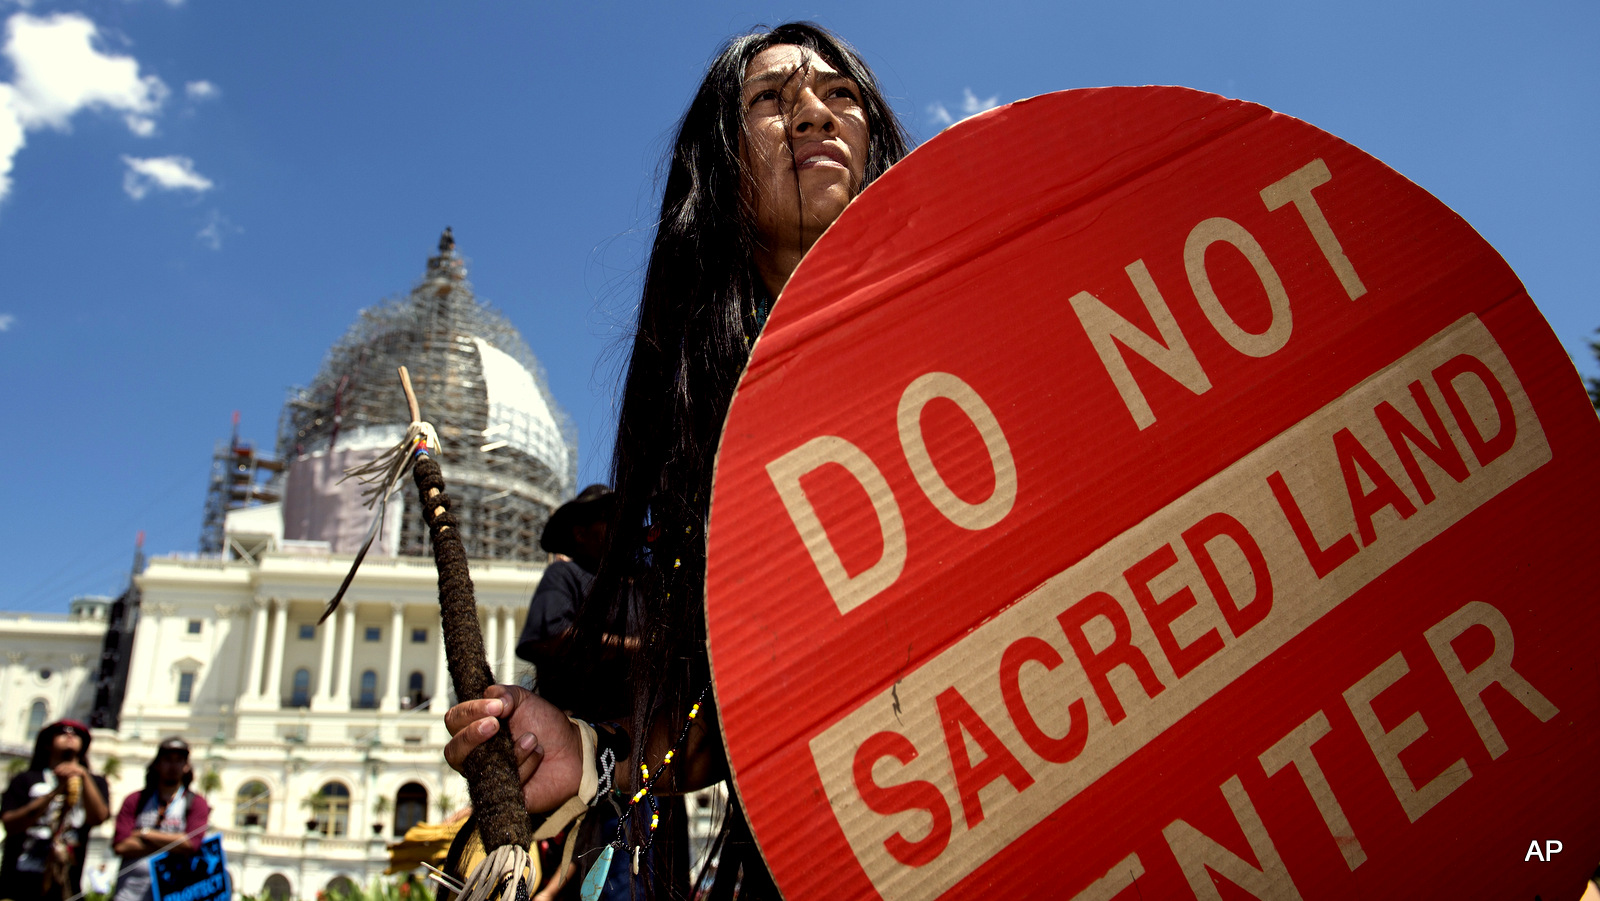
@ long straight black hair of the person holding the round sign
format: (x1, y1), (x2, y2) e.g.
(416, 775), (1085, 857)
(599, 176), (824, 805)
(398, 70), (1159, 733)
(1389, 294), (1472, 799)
(571, 22), (910, 896)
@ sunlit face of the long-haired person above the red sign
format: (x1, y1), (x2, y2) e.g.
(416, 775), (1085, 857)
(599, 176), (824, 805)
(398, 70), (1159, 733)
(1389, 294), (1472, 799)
(739, 43), (869, 253)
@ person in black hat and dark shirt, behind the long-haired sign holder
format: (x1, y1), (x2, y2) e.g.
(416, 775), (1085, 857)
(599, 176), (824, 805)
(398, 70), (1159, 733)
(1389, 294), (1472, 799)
(517, 485), (637, 720)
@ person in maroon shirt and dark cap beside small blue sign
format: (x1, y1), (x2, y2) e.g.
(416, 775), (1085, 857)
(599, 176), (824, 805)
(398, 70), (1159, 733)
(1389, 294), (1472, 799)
(110, 738), (211, 901)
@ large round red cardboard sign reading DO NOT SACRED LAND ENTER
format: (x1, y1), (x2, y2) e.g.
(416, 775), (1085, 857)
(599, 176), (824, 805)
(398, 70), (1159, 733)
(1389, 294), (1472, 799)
(707, 88), (1600, 901)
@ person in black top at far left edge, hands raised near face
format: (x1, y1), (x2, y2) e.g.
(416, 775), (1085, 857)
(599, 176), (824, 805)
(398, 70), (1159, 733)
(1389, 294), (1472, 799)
(0, 720), (110, 901)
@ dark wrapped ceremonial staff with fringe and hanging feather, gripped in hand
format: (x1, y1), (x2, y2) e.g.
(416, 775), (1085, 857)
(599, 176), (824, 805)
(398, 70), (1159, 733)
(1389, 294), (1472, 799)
(322, 366), (539, 901)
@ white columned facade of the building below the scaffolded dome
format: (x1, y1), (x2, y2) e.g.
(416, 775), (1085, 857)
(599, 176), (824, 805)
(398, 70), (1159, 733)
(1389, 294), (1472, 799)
(0, 547), (544, 898)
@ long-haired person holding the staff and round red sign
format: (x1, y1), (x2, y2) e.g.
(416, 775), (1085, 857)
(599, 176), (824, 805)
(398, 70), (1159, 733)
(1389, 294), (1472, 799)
(445, 22), (909, 898)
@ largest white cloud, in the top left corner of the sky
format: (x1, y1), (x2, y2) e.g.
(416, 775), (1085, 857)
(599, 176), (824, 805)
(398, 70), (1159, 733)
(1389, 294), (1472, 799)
(0, 13), (170, 198)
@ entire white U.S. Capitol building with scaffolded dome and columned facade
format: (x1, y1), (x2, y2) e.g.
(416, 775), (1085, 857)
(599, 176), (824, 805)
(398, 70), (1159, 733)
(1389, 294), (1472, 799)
(0, 232), (576, 898)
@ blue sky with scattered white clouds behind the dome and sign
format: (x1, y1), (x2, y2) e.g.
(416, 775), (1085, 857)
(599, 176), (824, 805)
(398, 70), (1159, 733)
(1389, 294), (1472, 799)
(0, 0), (1600, 611)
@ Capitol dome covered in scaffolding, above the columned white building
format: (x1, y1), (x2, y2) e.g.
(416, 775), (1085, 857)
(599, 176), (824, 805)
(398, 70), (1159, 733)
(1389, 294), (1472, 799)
(277, 229), (578, 560)
